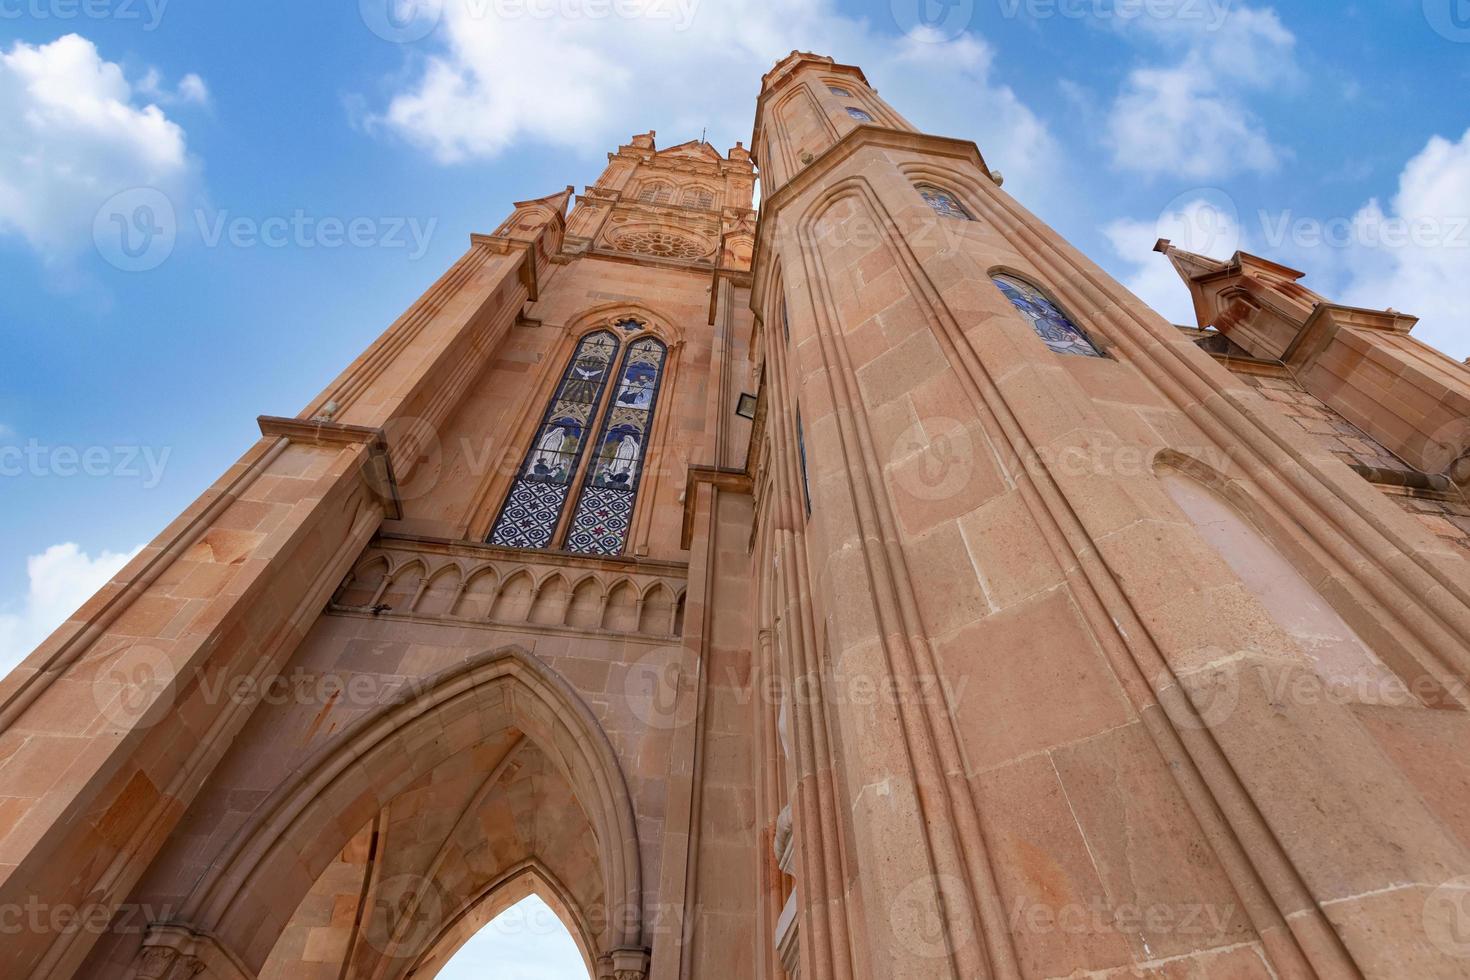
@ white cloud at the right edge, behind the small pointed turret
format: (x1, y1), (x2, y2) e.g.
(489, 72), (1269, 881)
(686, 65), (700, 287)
(1103, 131), (1470, 360)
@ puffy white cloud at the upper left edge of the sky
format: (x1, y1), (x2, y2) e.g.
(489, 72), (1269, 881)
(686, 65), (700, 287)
(0, 34), (207, 259)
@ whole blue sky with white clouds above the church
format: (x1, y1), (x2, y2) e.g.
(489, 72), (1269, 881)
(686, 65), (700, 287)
(0, 0), (1470, 975)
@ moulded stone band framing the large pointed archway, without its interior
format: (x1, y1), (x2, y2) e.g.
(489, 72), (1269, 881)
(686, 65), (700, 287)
(144, 646), (644, 970)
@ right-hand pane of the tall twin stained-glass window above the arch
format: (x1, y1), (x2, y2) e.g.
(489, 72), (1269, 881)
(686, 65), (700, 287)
(566, 336), (667, 555)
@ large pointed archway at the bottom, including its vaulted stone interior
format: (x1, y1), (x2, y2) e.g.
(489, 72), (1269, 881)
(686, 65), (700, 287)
(123, 648), (647, 980)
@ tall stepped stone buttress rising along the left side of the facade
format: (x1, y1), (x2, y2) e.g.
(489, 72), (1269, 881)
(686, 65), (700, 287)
(0, 207), (564, 976)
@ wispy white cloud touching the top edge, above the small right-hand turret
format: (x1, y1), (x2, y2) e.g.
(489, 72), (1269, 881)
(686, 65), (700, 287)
(1107, 4), (1298, 179)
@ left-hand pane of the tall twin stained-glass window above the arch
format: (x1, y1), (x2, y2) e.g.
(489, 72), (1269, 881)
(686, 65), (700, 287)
(490, 331), (617, 548)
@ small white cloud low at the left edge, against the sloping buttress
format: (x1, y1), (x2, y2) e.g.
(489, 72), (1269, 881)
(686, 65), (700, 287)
(0, 542), (141, 674)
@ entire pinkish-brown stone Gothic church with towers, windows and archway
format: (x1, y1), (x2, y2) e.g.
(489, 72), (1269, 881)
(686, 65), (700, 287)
(0, 53), (1470, 980)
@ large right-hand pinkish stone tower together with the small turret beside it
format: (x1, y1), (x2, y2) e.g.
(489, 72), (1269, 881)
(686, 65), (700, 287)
(751, 53), (1470, 979)
